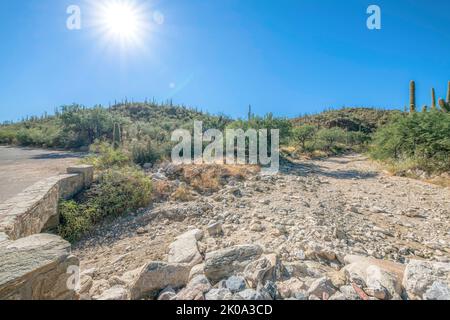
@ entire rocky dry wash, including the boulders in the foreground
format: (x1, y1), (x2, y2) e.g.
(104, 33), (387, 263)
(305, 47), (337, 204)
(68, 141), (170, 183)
(74, 155), (450, 300)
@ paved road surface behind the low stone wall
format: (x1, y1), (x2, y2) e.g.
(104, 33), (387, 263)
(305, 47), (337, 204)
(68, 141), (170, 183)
(0, 146), (81, 203)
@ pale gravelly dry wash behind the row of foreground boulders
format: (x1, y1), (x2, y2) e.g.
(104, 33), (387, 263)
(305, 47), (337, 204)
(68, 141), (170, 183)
(74, 155), (450, 280)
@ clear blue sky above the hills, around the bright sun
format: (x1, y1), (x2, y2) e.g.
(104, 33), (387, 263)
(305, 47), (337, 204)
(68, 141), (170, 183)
(0, 0), (450, 121)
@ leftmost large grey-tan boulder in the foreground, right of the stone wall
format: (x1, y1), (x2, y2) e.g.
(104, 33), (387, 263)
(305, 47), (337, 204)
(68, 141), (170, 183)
(125, 262), (191, 300)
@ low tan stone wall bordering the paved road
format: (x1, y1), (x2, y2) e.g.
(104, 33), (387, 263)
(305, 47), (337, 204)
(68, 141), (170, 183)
(0, 166), (94, 300)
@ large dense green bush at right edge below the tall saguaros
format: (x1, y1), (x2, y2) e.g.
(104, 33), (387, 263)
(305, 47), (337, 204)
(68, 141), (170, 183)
(370, 111), (450, 172)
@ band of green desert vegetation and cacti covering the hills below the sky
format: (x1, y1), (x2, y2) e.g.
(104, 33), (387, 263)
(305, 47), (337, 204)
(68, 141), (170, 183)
(0, 89), (450, 173)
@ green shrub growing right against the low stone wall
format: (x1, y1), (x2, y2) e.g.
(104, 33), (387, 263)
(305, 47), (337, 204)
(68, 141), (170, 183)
(59, 167), (152, 242)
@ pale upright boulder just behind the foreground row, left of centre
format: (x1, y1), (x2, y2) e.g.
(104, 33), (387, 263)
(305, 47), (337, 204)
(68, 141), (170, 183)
(168, 229), (203, 266)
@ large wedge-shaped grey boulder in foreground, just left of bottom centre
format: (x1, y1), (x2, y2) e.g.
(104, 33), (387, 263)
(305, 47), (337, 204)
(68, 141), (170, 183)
(204, 244), (263, 283)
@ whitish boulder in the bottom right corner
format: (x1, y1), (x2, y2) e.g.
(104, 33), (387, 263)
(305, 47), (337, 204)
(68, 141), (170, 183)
(403, 260), (450, 300)
